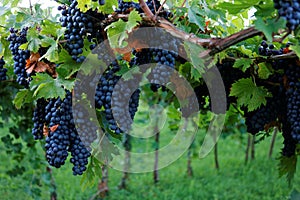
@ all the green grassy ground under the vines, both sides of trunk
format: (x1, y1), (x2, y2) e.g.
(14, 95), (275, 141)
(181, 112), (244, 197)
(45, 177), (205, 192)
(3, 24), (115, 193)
(0, 127), (300, 200)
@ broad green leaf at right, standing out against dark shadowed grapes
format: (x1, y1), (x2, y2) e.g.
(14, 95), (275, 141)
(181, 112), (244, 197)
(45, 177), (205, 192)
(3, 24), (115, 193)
(230, 78), (272, 111)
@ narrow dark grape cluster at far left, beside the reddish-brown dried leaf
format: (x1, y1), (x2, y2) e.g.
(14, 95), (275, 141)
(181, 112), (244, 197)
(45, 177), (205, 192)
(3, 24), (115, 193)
(7, 28), (31, 87)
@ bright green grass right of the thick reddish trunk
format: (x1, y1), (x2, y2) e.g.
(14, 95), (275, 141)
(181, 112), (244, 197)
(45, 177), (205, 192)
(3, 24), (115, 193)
(101, 134), (300, 200)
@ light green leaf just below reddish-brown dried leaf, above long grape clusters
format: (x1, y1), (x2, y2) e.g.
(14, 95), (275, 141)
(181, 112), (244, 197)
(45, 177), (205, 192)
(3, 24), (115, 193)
(29, 73), (74, 99)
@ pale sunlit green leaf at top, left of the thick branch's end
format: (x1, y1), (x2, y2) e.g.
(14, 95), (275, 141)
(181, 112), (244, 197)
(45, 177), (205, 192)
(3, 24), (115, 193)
(105, 10), (142, 48)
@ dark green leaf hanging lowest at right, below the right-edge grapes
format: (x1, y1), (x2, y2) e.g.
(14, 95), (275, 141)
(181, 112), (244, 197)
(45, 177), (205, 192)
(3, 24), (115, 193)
(278, 155), (297, 185)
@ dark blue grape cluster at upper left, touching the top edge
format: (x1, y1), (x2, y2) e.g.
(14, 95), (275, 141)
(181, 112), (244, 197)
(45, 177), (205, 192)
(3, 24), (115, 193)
(58, 0), (104, 63)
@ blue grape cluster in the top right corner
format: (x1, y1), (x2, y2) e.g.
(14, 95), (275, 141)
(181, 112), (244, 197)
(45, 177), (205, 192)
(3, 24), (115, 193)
(273, 0), (300, 30)
